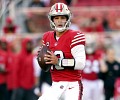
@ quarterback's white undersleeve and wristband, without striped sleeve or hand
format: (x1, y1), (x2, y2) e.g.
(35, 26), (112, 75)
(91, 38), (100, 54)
(58, 45), (86, 70)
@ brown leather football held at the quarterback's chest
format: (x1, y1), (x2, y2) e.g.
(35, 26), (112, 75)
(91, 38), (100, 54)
(37, 45), (52, 72)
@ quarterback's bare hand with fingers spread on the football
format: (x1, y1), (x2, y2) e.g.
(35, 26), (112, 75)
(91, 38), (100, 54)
(44, 51), (58, 65)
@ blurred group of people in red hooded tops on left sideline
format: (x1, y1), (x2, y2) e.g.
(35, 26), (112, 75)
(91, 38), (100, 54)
(0, 37), (51, 100)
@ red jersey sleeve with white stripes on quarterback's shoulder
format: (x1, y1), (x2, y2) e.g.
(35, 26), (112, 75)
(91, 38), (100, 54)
(70, 31), (85, 48)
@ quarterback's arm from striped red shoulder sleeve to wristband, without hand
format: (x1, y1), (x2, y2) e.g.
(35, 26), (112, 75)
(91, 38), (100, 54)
(59, 32), (86, 70)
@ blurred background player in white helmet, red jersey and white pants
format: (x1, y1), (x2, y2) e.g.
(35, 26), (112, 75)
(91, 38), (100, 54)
(82, 37), (103, 100)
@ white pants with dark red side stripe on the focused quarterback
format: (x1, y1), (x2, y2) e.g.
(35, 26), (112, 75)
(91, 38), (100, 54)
(38, 81), (82, 100)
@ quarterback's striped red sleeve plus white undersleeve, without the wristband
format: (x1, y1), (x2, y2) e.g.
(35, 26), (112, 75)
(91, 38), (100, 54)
(70, 31), (86, 70)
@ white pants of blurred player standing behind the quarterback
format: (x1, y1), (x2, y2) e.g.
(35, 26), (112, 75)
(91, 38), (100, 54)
(82, 79), (104, 100)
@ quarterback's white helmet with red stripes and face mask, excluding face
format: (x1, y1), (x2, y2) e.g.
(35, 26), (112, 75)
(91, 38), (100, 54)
(48, 3), (71, 32)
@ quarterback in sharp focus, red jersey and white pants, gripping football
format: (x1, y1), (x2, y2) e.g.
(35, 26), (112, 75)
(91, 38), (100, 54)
(38, 3), (86, 100)
